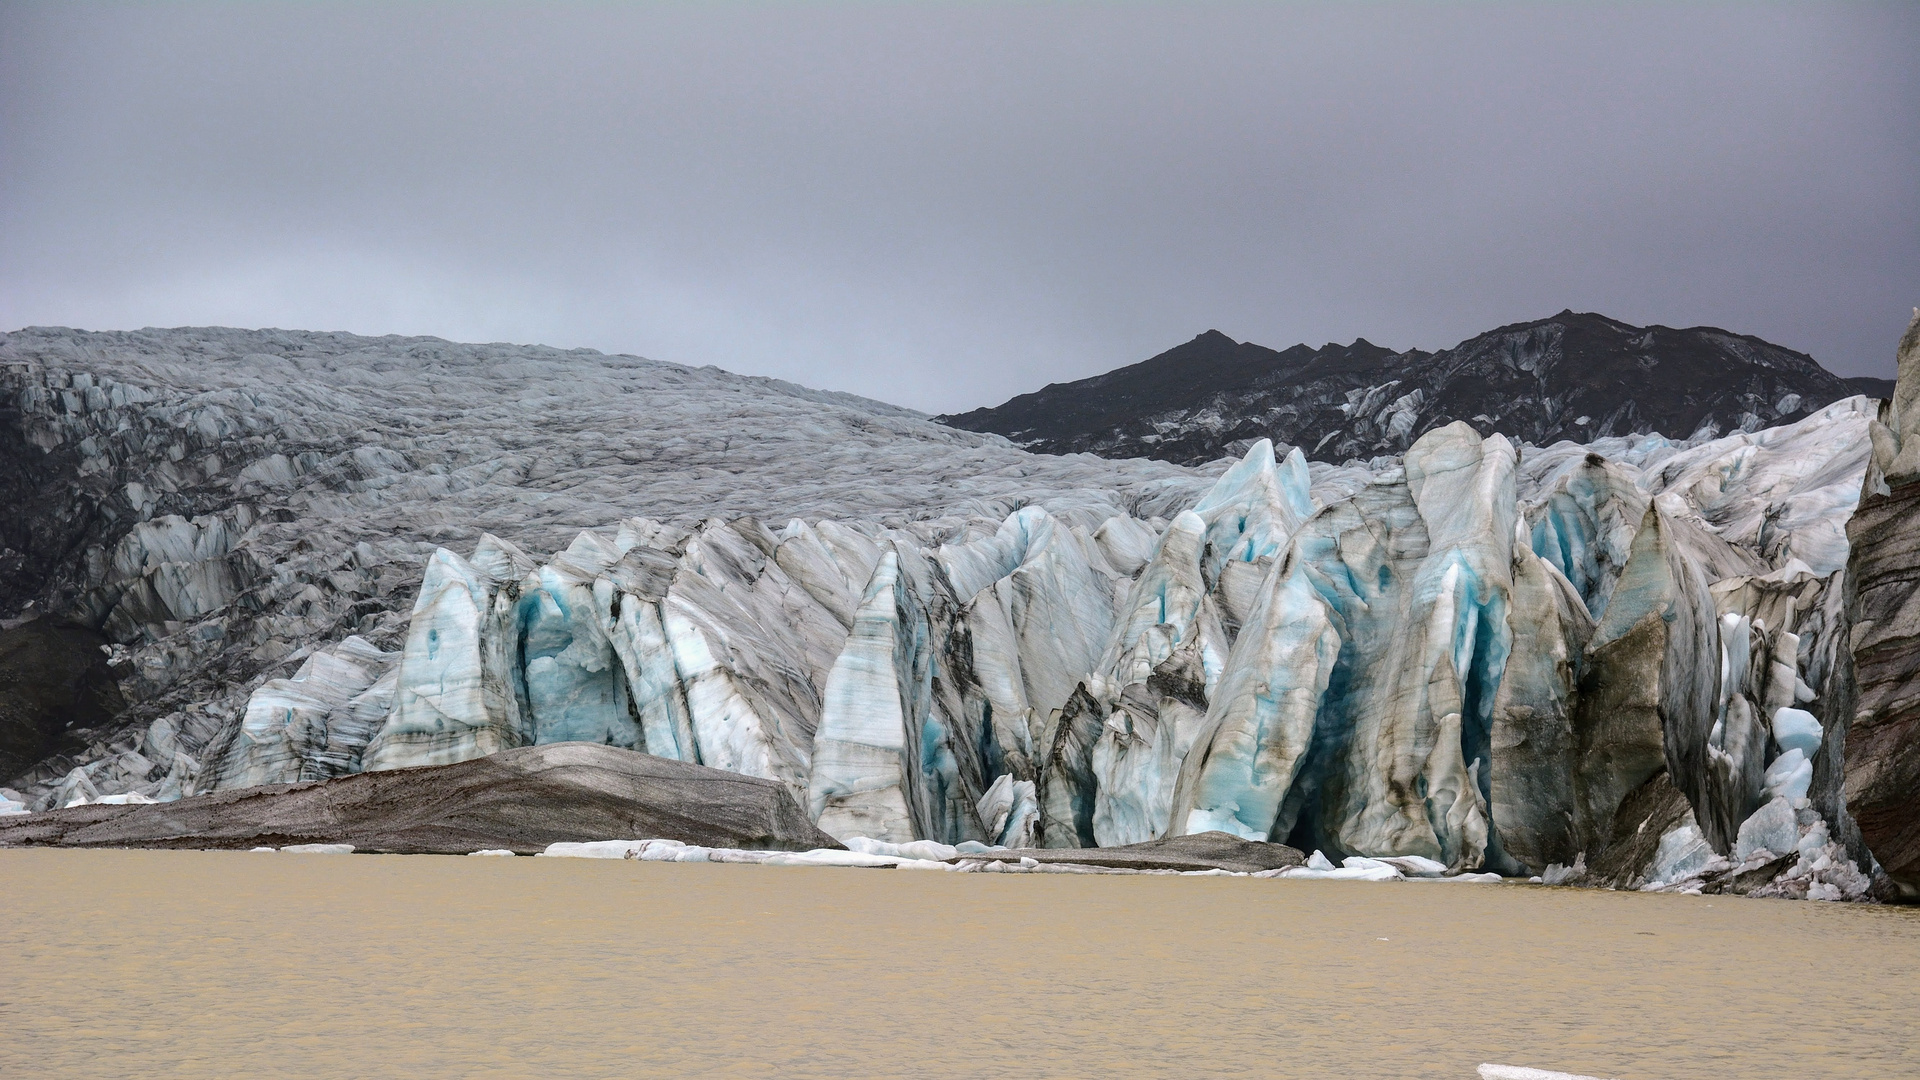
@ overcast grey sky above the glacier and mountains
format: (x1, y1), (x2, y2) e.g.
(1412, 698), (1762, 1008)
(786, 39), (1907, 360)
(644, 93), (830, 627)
(0, 2), (1920, 411)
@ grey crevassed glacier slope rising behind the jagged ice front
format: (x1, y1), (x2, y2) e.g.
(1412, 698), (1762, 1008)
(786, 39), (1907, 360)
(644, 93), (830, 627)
(0, 329), (1206, 799)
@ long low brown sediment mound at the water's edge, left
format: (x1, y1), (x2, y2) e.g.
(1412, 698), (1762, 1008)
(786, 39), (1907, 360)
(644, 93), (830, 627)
(0, 742), (839, 855)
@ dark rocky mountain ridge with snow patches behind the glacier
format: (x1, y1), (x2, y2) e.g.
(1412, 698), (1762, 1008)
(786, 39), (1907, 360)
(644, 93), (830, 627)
(939, 311), (1891, 463)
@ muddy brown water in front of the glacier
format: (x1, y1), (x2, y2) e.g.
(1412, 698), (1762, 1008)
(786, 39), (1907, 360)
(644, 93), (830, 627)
(0, 851), (1920, 1080)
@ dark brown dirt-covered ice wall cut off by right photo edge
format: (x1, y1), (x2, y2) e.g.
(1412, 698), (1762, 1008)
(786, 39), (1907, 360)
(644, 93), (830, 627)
(1845, 309), (1920, 899)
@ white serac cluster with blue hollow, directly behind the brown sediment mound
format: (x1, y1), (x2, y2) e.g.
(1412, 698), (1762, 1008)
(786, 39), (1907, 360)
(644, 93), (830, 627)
(351, 519), (843, 798)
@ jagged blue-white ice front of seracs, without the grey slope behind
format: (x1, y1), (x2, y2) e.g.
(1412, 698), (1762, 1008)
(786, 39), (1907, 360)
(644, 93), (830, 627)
(202, 402), (1870, 887)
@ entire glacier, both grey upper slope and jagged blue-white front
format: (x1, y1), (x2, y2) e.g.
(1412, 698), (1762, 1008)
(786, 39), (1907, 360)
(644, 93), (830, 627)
(0, 317), (1920, 896)
